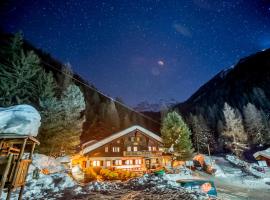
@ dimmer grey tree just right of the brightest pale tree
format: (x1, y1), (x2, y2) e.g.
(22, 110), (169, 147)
(244, 103), (264, 144)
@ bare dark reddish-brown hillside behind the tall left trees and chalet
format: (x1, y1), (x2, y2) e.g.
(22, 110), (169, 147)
(0, 31), (160, 143)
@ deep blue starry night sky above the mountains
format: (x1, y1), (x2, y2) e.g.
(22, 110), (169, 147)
(0, 0), (270, 105)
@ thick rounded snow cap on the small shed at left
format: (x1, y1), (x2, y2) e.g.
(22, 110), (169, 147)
(0, 105), (41, 136)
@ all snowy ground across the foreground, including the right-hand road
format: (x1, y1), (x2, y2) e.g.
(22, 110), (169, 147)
(2, 154), (270, 200)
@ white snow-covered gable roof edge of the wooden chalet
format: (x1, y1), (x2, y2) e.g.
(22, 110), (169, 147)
(80, 125), (162, 155)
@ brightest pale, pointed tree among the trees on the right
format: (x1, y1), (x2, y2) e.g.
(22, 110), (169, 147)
(223, 103), (247, 156)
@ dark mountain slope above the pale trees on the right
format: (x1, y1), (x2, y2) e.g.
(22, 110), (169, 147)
(173, 49), (270, 152)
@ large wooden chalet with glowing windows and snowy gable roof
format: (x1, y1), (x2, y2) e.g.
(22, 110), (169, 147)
(74, 126), (167, 171)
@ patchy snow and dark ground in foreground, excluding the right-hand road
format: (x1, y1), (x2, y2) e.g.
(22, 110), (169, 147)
(2, 154), (207, 200)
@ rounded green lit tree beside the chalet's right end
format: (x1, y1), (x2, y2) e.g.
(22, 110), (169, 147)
(161, 111), (193, 166)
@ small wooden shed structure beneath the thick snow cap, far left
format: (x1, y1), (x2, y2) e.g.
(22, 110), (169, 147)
(0, 134), (39, 199)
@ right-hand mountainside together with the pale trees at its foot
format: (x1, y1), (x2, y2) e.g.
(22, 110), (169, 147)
(173, 49), (270, 152)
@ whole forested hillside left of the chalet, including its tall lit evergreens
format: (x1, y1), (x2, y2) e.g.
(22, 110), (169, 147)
(0, 32), (160, 154)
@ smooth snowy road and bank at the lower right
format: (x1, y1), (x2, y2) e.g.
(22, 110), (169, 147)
(198, 156), (270, 200)
